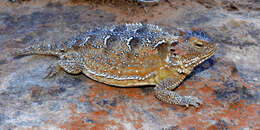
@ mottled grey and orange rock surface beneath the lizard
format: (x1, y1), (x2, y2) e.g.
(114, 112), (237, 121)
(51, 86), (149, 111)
(0, 0), (260, 130)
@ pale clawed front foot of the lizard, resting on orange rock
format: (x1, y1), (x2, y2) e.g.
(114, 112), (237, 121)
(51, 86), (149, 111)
(180, 96), (202, 107)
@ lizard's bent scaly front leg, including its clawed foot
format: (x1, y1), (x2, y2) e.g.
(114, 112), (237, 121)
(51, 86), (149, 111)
(154, 77), (202, 107)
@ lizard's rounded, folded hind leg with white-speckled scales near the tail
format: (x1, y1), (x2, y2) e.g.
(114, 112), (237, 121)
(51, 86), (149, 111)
(58, 53), (82, 74)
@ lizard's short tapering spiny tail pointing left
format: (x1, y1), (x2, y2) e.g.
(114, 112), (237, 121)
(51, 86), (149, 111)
(12, 43), (64, 57)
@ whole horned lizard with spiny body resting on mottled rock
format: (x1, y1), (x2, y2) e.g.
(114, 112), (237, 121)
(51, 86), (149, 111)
(16, 23), (217, 107)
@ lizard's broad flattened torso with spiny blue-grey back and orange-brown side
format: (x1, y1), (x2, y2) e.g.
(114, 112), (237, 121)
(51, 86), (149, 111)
(63, 24), (177, 87)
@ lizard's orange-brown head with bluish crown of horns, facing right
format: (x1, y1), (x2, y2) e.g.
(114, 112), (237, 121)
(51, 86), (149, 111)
(166, 36), (217, 74)
